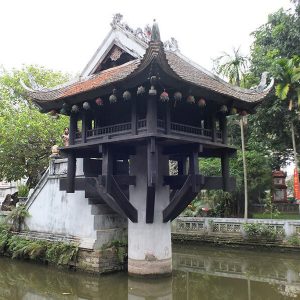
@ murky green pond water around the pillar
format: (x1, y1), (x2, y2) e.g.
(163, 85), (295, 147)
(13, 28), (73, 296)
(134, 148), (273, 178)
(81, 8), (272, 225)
(0, 246), (300, 300)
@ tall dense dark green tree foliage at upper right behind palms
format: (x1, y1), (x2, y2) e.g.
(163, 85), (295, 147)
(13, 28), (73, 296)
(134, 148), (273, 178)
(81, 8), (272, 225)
(249, 3), (300, 168)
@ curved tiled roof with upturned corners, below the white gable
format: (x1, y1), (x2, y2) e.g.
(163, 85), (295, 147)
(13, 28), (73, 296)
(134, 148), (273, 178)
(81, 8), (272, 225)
(22, 42), (273, 106)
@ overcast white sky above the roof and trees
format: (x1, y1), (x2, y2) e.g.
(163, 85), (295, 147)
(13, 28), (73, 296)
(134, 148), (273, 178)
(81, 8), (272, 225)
(0, 0), (290, 74)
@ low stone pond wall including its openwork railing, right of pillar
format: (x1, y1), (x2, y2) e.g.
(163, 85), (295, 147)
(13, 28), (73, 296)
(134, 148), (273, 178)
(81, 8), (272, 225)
(172, 217), (300, 248)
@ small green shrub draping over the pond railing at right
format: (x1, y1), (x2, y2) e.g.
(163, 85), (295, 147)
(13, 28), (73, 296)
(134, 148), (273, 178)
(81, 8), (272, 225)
(243, 223), (282, 240)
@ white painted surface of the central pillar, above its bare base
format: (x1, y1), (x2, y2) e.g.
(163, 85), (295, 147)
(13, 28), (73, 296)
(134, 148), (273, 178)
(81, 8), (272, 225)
(128, 147), (172, 260)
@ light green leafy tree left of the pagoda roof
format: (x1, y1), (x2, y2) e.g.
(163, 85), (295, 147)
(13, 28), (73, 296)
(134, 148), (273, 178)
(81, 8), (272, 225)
(0, 66), (67, 188)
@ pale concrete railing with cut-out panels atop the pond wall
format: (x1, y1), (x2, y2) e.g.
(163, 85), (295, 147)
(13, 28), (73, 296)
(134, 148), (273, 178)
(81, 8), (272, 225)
(172, 217), (300, 237)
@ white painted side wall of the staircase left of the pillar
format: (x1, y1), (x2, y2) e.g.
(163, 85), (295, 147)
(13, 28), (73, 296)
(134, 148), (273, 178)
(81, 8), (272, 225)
(26, 160), (96, 244)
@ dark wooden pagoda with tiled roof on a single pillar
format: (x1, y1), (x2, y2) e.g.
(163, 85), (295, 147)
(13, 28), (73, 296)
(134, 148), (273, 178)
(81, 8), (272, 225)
(22, 15), (272, 275)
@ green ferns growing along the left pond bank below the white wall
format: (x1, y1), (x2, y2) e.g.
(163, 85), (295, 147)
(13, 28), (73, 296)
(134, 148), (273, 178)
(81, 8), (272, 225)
(0, 226), (78, 265)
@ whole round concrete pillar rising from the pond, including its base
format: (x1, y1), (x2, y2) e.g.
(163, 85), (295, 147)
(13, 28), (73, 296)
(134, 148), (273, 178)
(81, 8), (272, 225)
(128, 146), (172, 275)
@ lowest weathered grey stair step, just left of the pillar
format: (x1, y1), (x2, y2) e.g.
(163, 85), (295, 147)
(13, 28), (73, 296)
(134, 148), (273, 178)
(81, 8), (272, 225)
(94, 228), (127, 249)
